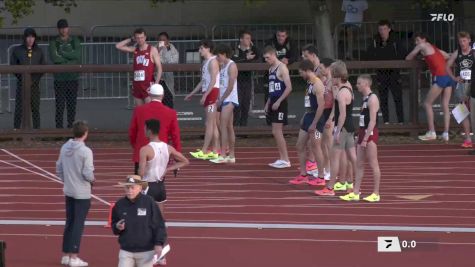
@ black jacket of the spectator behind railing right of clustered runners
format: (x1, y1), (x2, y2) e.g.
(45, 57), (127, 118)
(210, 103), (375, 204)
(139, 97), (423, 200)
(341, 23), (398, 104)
(366, 31), (407, 60)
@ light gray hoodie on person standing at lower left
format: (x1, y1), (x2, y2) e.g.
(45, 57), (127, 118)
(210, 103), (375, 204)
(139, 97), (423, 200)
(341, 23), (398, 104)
(56, 139), (95, 199)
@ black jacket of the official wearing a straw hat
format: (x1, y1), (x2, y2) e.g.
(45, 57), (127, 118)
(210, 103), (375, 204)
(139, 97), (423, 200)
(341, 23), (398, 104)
(112, 193), (167, 252)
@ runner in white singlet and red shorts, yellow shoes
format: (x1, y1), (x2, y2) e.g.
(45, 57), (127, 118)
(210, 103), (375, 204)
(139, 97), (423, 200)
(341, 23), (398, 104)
(185, 40), (219, 160)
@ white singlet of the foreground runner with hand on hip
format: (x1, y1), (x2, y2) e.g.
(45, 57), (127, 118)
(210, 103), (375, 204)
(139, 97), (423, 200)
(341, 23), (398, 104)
(143, 142), (170, 182)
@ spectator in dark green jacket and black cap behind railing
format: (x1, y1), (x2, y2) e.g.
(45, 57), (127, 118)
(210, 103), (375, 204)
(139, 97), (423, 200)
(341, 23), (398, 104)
(49, 19), (81, 128)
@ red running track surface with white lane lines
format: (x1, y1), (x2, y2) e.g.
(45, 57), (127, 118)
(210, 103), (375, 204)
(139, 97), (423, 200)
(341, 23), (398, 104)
(0, 144), (475, 267)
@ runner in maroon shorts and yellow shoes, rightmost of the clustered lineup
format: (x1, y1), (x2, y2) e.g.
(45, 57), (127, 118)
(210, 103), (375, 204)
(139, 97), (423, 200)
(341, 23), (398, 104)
(340, 74), (381, 202)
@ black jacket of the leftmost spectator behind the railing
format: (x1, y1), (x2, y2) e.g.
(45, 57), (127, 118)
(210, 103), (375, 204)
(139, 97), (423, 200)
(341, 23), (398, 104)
(10, 43), (46, 82)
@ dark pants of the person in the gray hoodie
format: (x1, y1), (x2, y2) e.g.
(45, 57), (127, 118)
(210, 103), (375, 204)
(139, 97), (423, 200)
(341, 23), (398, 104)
(63, 196), (91, 254)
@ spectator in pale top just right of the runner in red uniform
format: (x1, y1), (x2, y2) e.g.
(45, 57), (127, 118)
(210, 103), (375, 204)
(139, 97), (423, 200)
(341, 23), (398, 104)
(158, 32), (179, 97)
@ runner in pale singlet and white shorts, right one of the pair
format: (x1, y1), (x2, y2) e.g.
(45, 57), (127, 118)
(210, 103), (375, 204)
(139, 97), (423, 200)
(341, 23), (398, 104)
(211, 45), (239, 163)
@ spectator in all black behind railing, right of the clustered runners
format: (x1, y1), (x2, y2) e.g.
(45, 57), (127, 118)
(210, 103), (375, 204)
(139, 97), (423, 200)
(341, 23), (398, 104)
(367, 20), (406, 124)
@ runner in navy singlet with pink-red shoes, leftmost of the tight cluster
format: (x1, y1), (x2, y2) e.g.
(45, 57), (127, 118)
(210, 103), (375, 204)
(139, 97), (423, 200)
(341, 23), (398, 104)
(289, 60), (327, 185)
